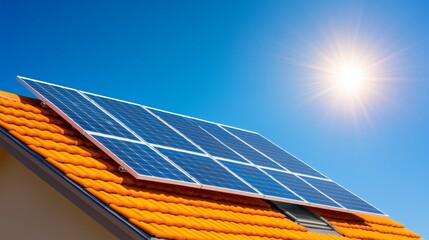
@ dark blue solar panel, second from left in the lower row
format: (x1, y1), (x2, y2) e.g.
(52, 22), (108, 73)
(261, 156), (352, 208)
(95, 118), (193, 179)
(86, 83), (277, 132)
(158, 148), (256, 193)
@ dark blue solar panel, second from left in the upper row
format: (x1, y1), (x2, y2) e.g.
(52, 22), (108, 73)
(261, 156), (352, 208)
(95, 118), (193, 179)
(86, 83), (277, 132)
(86, 94), (201, 153)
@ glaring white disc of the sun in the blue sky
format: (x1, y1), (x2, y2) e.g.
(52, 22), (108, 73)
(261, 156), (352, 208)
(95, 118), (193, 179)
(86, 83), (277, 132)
(332, 63), (369, 97)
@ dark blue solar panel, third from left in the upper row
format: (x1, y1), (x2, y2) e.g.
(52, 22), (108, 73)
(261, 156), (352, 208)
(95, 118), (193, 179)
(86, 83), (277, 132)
(149, 109), (246, 162)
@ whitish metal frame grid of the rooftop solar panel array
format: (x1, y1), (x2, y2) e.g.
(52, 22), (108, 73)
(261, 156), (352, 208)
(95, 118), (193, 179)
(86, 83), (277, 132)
(17, 76), (387, 216)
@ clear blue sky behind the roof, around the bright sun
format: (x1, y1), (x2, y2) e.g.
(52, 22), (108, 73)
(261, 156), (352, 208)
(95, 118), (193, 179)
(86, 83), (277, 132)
(0, 1), (429, 238)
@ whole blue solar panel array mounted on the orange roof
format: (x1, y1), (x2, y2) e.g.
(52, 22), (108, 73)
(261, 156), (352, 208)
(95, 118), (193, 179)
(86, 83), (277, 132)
(18, 77), (384, 215)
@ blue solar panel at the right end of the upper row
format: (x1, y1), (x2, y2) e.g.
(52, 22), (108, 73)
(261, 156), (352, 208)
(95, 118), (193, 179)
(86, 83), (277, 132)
(222, 126), (325, 178)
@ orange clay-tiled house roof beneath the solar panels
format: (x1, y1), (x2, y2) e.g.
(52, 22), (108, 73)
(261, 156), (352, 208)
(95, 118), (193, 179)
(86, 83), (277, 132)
(0, 91), (422, 240)
